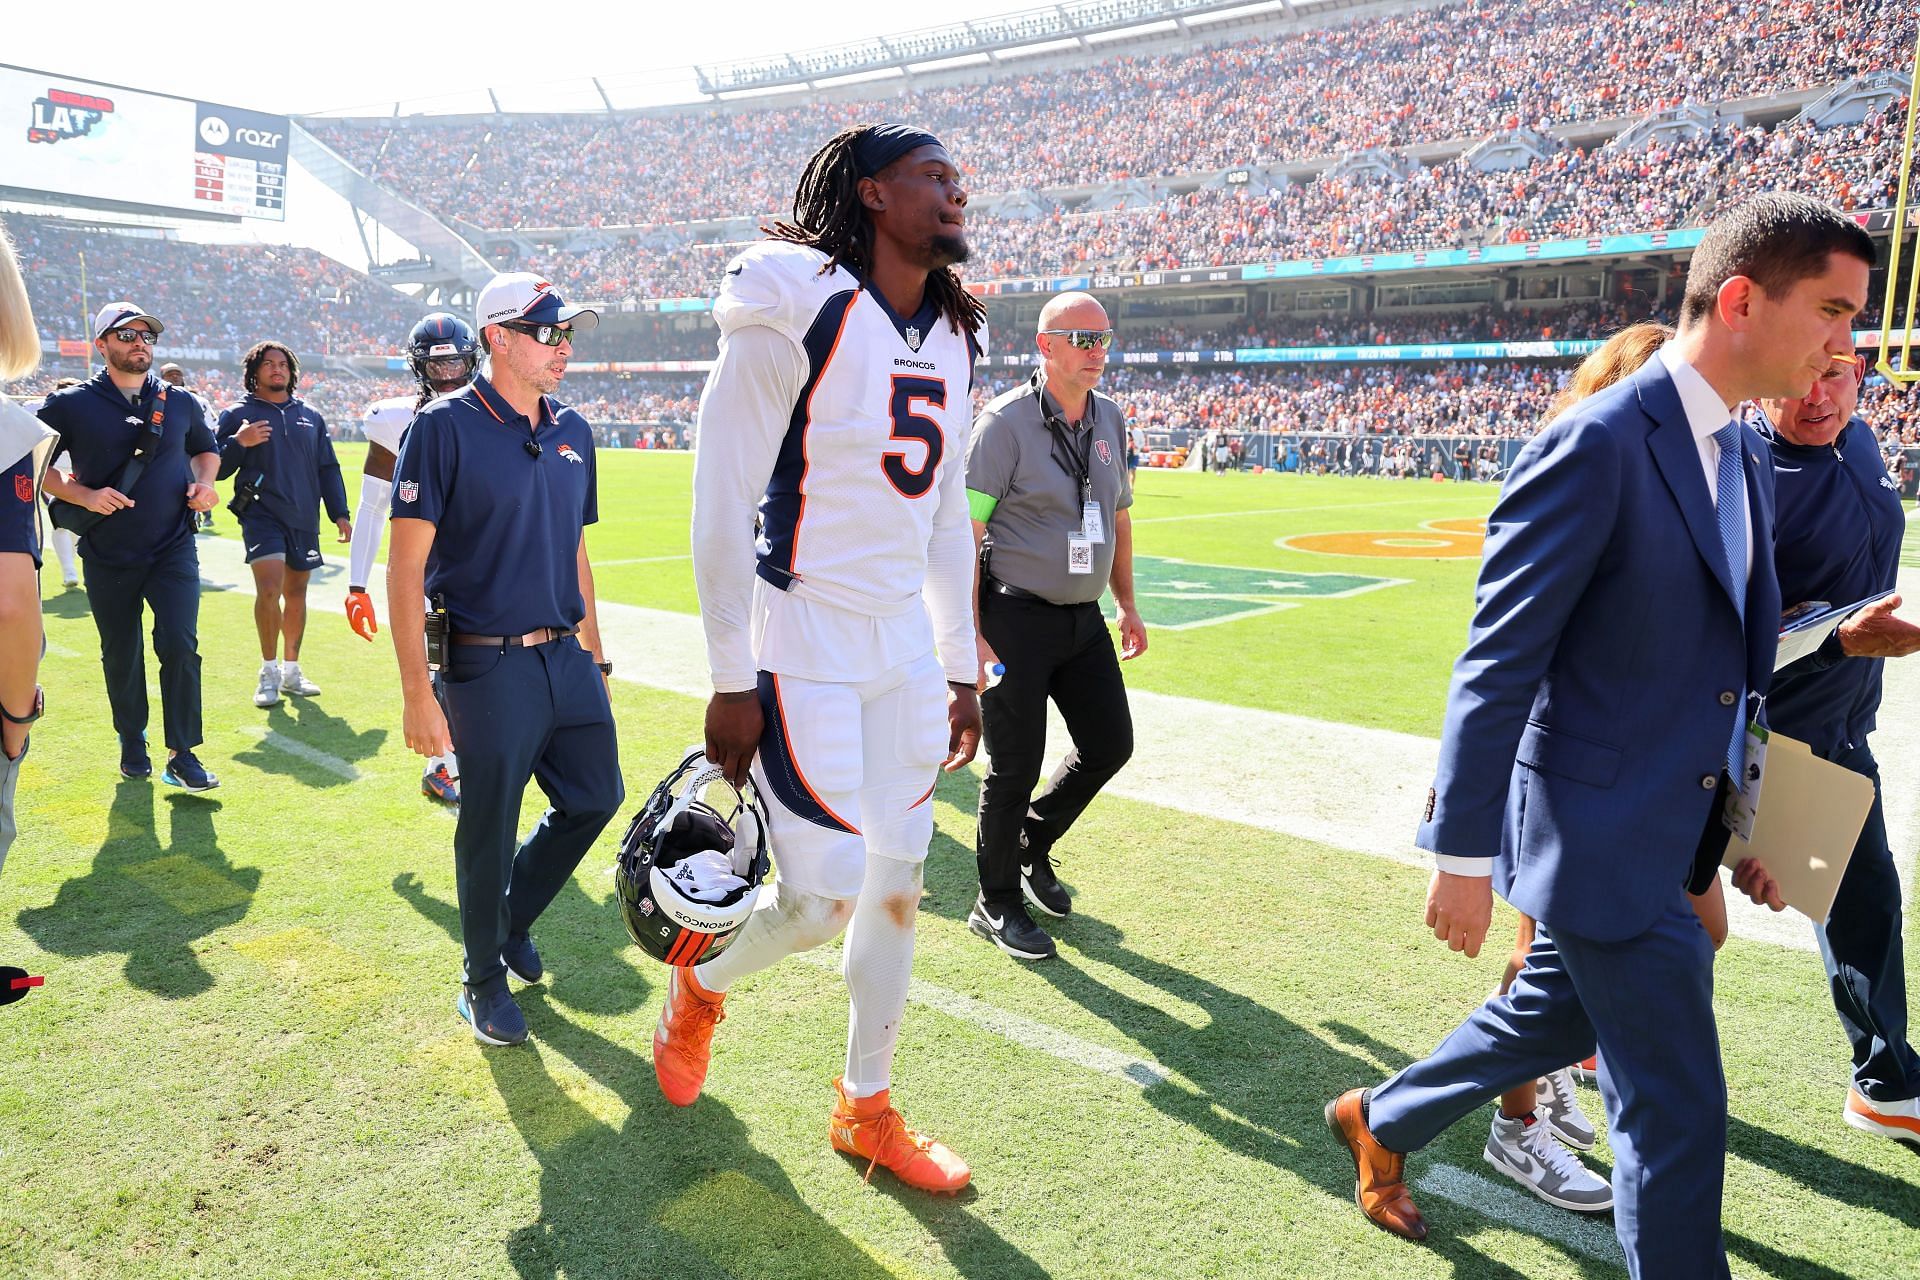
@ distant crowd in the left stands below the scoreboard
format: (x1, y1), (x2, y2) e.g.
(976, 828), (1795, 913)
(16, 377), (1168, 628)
(0, 213), (419, 357)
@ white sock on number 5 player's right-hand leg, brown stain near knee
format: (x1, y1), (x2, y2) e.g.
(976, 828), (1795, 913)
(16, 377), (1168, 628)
(841, 852), (924, 1098)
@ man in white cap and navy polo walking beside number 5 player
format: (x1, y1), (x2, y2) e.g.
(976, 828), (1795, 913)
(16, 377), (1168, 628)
(386, 273), (624, 1044)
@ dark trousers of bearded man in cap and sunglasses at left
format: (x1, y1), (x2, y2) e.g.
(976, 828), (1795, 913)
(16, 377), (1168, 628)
(86, 537), (200, 750)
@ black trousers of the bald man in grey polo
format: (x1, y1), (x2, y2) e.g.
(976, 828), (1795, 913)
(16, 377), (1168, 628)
(975, 587), (1133, 902)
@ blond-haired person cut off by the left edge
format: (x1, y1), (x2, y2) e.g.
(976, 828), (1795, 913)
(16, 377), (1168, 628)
(0, 228), (54, 865)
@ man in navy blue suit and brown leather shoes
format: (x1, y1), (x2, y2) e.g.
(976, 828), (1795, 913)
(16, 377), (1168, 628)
(1327, 194), (1874, 1280)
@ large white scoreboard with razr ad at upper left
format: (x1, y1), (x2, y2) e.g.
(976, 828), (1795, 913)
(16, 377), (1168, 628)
(0, 65), (288, 223)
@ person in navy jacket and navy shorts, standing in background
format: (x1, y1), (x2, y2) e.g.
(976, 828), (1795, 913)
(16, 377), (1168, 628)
(219, 342), (353, 706)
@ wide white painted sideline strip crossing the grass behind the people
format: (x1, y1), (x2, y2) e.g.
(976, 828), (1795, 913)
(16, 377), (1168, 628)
(200, 537), (1920, 950)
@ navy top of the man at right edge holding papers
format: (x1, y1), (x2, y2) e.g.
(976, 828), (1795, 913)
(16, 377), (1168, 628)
(1766, 418), (1907, 758)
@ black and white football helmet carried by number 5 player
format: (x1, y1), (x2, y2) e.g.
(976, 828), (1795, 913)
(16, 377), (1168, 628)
(614, 750), (772, 967)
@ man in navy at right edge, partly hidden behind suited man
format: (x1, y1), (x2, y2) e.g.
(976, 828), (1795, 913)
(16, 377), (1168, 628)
(1741, 359), (1920, 1144)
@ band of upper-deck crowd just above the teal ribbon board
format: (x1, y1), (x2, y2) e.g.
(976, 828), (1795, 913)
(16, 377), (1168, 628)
(528, 102), (1907, 299)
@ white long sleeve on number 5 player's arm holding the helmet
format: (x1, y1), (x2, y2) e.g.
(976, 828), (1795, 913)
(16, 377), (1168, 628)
(693, 324), (806, 693)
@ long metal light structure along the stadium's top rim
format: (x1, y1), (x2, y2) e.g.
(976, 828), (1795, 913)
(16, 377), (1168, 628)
(693, 0), (1308, 98)
